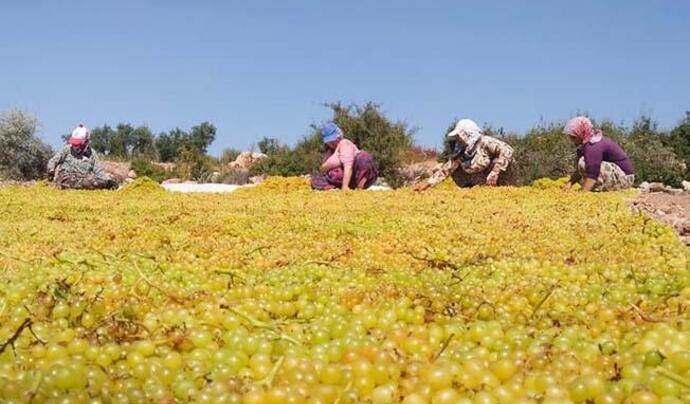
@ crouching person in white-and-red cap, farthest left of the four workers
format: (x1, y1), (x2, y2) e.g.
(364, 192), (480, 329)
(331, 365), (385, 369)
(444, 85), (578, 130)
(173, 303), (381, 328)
(48, 123), (117, 189)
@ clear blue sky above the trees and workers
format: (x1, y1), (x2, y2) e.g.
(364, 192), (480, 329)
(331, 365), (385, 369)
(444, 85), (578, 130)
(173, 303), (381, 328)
(0, 0), (690, 154)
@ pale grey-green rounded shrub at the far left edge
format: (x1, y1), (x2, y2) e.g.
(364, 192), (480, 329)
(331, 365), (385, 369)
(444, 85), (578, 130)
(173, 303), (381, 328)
(0, 110), (52, 180)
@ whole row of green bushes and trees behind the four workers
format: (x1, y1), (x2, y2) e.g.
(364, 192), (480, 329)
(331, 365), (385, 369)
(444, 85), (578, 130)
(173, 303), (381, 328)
(0, 103), (690, 186)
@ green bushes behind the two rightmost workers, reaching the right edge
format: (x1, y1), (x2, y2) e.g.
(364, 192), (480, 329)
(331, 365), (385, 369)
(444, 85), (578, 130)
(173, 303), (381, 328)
(439, 117), (690, 186)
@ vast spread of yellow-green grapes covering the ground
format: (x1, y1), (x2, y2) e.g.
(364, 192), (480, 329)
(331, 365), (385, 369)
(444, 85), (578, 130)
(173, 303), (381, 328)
(0, 179), (690, 404)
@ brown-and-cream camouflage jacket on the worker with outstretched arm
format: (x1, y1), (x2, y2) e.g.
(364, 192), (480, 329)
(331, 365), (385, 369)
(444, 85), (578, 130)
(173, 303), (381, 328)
(427, 136), (513, 186)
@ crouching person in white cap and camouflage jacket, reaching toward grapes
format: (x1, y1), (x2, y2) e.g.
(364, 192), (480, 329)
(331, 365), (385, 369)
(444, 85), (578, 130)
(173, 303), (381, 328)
(414, 119), (515, 191)
